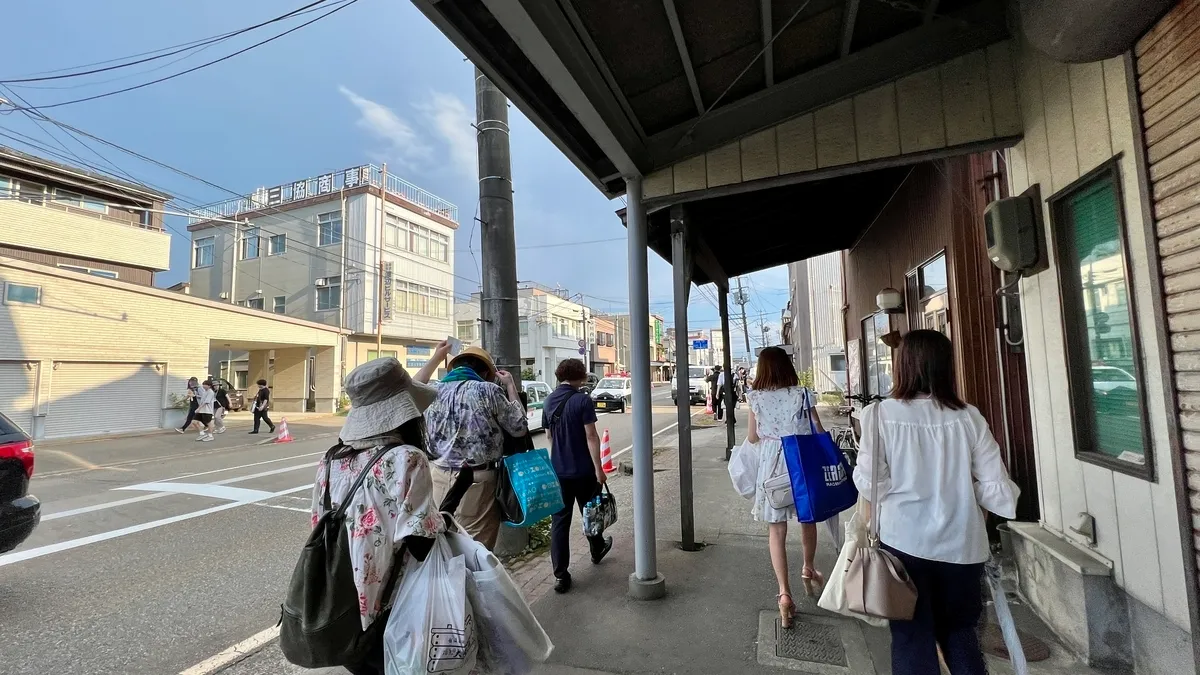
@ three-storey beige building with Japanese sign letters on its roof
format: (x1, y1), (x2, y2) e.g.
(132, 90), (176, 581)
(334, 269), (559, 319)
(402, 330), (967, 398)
(188, 165), (458, 372)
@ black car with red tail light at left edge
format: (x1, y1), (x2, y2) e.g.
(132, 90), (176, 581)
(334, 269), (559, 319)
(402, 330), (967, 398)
(0, 413), (42, 554)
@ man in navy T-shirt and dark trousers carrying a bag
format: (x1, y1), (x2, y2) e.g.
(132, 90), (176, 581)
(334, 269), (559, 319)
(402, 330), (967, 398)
(542, 359), (612, 593)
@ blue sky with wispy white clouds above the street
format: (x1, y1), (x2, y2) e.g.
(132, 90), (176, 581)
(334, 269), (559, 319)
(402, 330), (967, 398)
(0, 0), (787, 357)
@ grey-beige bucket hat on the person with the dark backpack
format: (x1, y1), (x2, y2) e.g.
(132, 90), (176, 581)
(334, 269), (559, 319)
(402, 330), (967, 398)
(340, 357), (438, 443)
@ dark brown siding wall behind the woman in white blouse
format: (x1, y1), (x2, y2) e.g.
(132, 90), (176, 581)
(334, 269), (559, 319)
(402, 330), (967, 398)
(846, 154), (1038, 520)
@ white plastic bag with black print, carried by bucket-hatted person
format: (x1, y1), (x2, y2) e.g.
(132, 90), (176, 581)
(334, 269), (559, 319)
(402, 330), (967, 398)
(383, 537), (478, 675)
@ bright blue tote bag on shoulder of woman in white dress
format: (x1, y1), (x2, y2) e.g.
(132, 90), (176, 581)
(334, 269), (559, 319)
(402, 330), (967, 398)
(781, 402), (858, 522)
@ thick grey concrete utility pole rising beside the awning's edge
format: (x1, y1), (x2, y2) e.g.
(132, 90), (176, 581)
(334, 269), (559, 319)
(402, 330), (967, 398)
(475, 68), (520, 554)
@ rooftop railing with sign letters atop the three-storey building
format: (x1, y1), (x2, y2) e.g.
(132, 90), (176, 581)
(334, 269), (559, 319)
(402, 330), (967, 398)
(191, 165), (458, 222)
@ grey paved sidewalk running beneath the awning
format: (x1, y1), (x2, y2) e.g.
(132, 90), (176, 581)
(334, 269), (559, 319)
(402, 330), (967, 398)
(211, 408), (1096, 675)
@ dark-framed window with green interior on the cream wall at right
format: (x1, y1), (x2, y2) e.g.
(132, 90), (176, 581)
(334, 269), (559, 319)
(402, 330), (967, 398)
(1050, 162), (1153, 478)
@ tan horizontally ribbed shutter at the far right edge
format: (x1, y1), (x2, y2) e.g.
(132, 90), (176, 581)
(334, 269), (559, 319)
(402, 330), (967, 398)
(1134, 0), (1200, 590)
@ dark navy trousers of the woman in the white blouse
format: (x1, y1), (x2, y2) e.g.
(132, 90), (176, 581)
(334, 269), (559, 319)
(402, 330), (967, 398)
(884, 545), (988, 675)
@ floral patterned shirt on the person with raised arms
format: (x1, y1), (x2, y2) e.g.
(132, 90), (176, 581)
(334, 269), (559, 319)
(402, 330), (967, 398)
(425, 381), (529, 468)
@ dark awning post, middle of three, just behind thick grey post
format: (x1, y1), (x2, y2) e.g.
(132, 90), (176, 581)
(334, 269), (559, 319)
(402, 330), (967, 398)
(671, 204), (700, 551)
